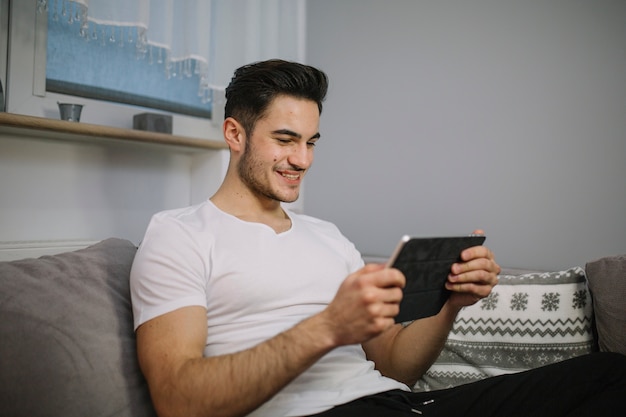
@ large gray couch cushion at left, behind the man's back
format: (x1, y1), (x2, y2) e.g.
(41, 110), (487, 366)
(0, 239), (155, 417)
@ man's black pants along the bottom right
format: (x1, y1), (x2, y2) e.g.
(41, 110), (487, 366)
(308, 353), (626, 417)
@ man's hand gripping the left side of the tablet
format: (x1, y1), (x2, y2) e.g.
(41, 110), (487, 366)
(321, 264), (405, 346)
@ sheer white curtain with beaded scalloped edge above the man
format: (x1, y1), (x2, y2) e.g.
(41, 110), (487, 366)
(38, 0), (306, 98)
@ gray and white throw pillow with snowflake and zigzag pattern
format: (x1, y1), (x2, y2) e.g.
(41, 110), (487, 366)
(414, 267), (594, 391)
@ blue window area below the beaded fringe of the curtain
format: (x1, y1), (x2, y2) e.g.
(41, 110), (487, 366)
(45, 0), (211, 118)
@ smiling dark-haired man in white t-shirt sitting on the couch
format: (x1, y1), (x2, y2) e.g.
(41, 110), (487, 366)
(131, 60), (624, 417)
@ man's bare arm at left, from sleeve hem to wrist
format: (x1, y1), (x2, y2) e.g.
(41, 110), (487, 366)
(144, 317), (334, 417)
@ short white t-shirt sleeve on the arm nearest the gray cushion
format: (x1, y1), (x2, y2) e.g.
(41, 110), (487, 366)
(130, 213), (208, 329)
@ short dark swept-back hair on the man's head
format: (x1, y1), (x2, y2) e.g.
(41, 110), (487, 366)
(224, 59), (328, 136)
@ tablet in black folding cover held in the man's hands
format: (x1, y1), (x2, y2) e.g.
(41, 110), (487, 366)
(387, 235), (485, 323)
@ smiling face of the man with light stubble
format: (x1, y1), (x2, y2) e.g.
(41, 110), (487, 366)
(238, 96), (320, 203)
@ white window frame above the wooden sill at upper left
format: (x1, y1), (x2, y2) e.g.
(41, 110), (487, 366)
(0, 0), (223, 139)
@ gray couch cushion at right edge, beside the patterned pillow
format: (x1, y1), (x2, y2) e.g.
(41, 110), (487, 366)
(585, 255), (626, 355)
